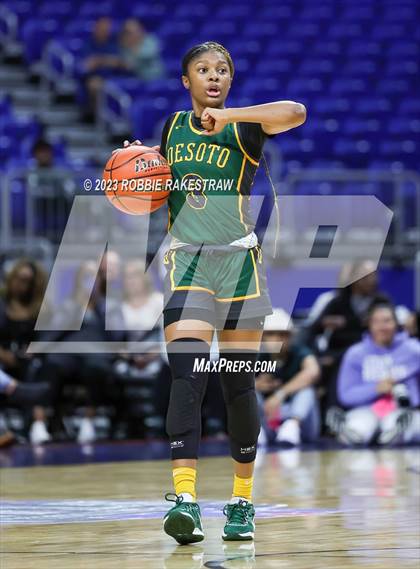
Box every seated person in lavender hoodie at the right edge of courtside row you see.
[327,304,420,445]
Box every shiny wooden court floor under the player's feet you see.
[0,449,420,569]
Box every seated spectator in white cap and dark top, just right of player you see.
[256,309,320,446]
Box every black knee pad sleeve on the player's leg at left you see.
[166,338,210,459]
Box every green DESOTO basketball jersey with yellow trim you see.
[161,111,262,245]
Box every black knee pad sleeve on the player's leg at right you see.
[220,350,261,462]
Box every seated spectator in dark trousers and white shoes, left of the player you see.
[30,253,124,444]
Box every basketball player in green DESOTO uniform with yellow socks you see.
[125,42,306,544]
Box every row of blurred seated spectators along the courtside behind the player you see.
[0,251,420,446]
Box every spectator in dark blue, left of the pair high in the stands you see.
[83,17,124,120]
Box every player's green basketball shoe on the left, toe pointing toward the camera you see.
[163,493,204,545]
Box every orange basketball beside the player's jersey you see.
[103,146,172,215]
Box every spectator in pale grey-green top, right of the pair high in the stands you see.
[120,18,164,81]
